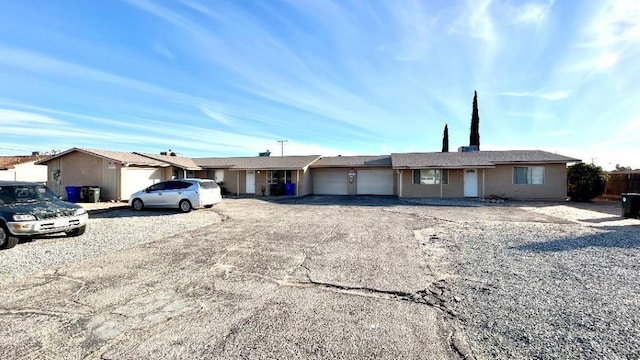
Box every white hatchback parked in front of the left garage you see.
[129,179,222,212]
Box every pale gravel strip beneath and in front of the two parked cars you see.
[0,208,221,281]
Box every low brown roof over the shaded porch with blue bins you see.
[193,155,320,170]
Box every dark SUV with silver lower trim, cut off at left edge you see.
[0,181,89,249]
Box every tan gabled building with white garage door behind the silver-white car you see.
[36,148,172,201]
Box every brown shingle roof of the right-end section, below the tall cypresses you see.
[391,150,580,169]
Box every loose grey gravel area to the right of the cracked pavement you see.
[404,204,640,359]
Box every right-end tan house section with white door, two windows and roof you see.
[391,150,580,200]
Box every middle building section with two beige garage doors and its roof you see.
[311,155,396,195]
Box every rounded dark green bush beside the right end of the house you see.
[567,163,607,202]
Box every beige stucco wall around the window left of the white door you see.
[396,169,462,198]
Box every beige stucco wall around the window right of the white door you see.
[479,163,567,200]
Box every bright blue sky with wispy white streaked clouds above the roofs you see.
[0,0,640,169]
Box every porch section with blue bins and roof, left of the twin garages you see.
[193,155,320,196]
